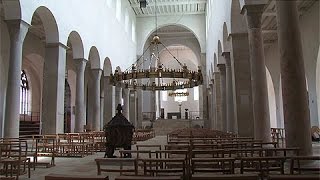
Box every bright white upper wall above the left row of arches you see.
[7,0,136,68]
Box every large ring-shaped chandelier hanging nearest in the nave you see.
[110,0,203,91]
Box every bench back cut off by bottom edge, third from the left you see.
[191,174,260,180]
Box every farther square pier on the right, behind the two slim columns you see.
[213,72,223,131]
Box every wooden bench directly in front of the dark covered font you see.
[95,158,138,175]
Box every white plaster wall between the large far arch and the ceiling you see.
[136,15,206,54]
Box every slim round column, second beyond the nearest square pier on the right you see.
[217,64,228,132]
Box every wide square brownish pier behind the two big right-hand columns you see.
[230,33,254,137]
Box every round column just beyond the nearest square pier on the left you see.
[74,59,87,132]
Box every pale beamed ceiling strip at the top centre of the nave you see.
[128,0,207,17]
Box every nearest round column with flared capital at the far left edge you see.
[3,20,30,138]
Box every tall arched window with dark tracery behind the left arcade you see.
[20,70,29,114]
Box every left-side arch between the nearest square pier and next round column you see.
[67,31,84,59]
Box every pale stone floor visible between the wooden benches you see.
[11,136,320,180]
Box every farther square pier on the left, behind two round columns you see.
[103,76,113,125]
